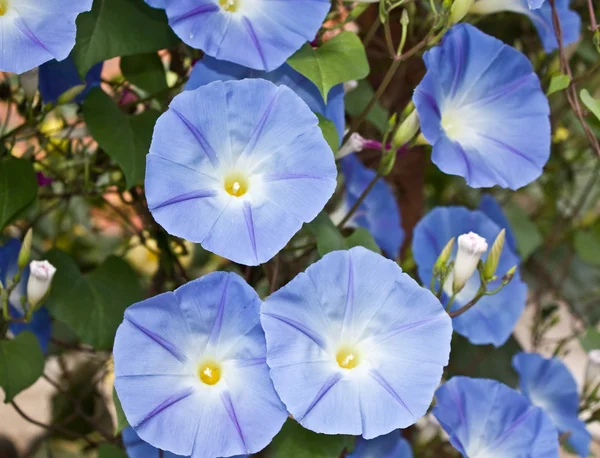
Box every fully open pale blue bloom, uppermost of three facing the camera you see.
[146,79,337,265]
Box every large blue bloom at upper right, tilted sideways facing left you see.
[413,24,550,189]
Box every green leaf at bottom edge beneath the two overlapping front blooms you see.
[266,420,354,458]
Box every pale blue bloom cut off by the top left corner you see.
[0,0,93,73]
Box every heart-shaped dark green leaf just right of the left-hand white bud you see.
[46,250,143,350]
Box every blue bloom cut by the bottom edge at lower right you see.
[433,377,558,458]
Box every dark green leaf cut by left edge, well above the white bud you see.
[0,158,38,230]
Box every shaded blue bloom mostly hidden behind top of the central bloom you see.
[185,56,345,141]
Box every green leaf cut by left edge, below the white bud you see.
[0,332,44,403]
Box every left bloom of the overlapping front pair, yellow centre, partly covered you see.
[114,272,287,458]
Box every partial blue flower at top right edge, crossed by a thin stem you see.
[471,0,581,53]
